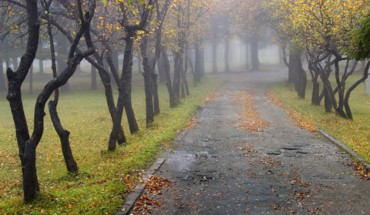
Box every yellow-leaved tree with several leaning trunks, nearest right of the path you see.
[266,0,369,119]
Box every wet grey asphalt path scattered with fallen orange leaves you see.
[132,71,370,215]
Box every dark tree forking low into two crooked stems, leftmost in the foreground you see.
[7,0,95,202]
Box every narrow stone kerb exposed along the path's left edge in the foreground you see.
[115,157,166,215]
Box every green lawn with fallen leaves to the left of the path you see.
[0,73,222,214]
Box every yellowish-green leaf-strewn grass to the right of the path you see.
[272,75,370,162]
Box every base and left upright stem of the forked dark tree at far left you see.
[7,0,40,202]
